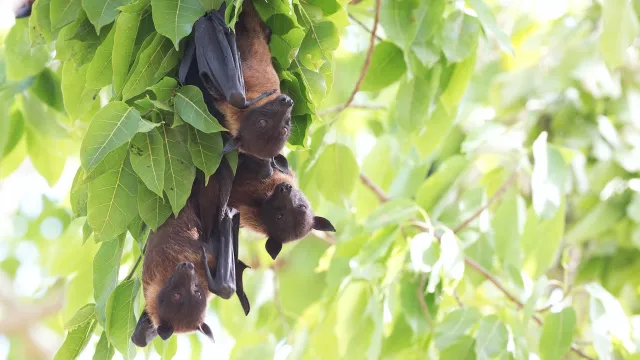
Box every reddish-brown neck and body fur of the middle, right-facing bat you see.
[229,169,297,235]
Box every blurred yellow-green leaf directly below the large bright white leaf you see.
[520,200,566,279]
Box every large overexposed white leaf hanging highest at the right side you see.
[531,132,569,219]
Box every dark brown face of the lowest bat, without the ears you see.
[156,262,207,339]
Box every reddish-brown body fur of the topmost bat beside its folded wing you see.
[215,0,280,136]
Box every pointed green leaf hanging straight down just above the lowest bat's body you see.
[161,125,196,216]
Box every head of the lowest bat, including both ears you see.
[131,262,213,347]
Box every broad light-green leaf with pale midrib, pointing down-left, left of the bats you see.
[80,101,141,172]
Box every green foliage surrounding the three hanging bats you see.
[0,0,640,359]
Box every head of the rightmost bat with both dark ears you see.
[260,182,336,259]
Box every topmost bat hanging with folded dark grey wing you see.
[179,0,293,159]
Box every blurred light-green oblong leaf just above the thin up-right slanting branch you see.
[416,155,469,213]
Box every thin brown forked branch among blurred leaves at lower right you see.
[360,170,594,360]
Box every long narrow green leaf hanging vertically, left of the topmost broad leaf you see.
[111,5,150,94]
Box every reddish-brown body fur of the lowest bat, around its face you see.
[142,201,216,332]
